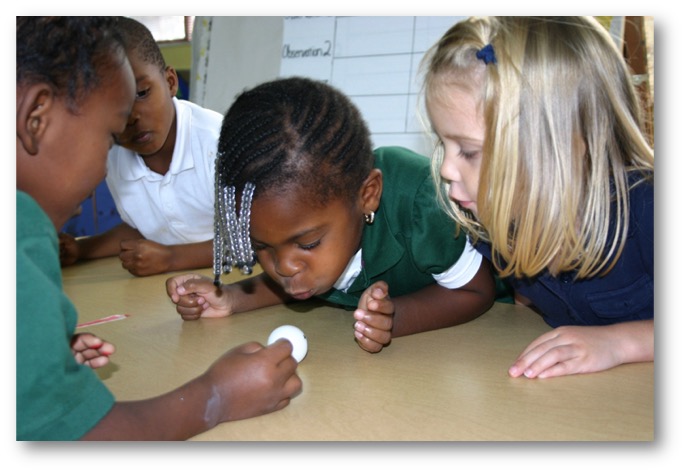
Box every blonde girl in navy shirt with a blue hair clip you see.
[424,17,654,378]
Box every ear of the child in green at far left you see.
[17,83,55,156]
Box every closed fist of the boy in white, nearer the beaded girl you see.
[119,239,174,277]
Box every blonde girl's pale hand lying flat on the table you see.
[509,326,622,379]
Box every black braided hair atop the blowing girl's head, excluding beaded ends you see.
[216,77,374,205]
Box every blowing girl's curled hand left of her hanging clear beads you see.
[166,274,231,320]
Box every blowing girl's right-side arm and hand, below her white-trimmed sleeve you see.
[354,258,495,352]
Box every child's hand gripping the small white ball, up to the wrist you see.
[205,340,302,422]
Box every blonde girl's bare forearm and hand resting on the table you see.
[509,320,654,379]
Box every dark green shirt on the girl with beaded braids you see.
[319,147,466,309]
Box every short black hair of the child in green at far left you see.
[17,16,123,111]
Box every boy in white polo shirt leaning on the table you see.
[60,17,223,276]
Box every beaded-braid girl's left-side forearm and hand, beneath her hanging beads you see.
[166,273,291,320]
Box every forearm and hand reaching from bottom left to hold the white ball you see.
[82,340,302,441]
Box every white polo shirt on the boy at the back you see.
[106,98,223,245]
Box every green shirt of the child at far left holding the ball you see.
[17,192,114,441]
